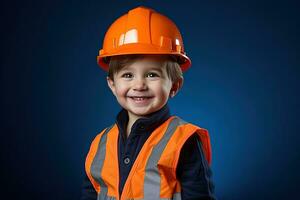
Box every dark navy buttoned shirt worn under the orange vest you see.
[81,105,215,200]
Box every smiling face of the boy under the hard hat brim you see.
[107,56,176,119]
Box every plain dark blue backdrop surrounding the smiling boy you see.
[0,0,300,200]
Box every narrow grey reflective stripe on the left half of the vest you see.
[91,125,113,200]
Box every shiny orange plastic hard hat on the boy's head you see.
[97,7,191,71]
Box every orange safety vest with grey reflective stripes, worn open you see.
[85,116,211,200]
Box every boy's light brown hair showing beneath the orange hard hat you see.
[108,54,183,83]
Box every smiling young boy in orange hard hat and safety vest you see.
[81,7,215,200]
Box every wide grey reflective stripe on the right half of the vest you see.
[144,117,186,200]
